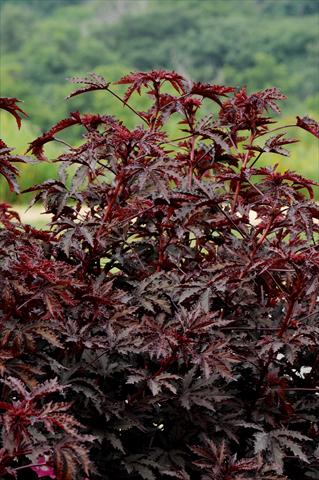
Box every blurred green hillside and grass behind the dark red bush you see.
[0,0,319,202]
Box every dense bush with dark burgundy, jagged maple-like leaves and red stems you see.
[0,71,319,480]
